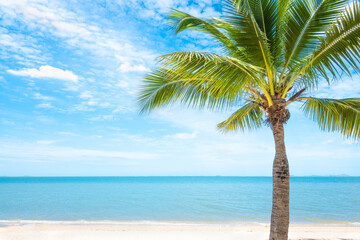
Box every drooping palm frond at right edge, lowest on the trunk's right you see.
[302,98,360,139]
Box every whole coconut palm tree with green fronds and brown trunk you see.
[138,0,360,240]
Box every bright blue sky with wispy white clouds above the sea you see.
[0,0,360,176]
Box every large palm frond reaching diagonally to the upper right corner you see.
[283,1,360,97]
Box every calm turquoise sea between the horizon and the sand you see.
[0,177,360,223]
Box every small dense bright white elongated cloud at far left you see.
[7,65,79,82]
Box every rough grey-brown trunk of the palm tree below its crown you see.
[270,123,290,240]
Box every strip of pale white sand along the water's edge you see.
[0,222,360,240]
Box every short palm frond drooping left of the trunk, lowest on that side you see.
[217,102,263,132]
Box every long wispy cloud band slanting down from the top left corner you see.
[0,0,156,66]
